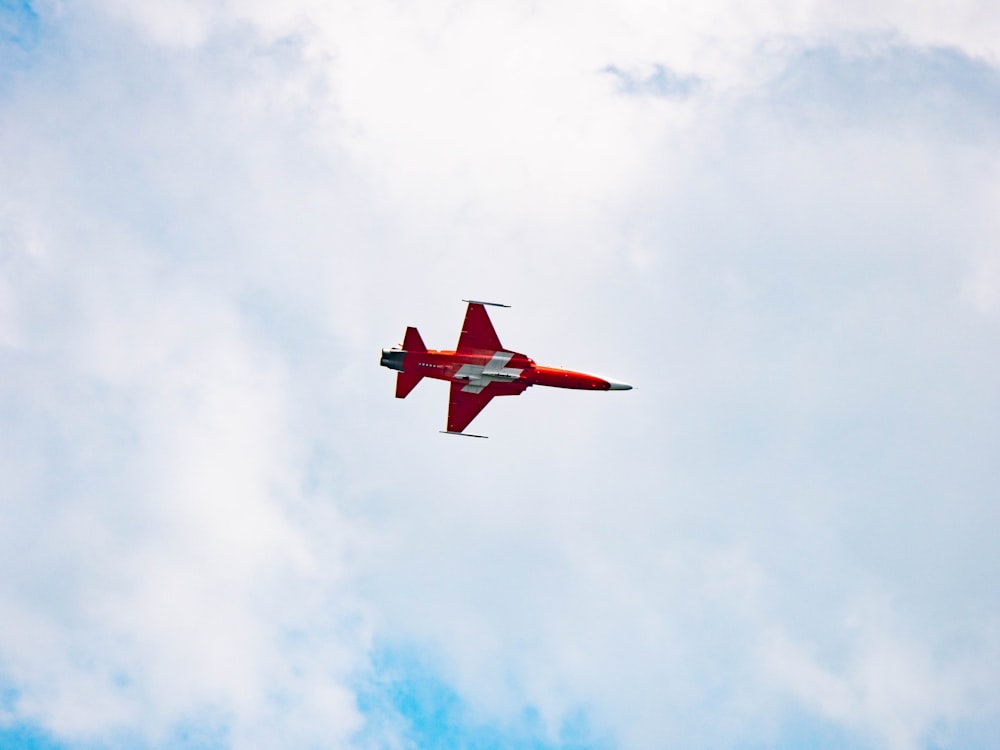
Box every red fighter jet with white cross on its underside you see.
[380,300,632,437]
